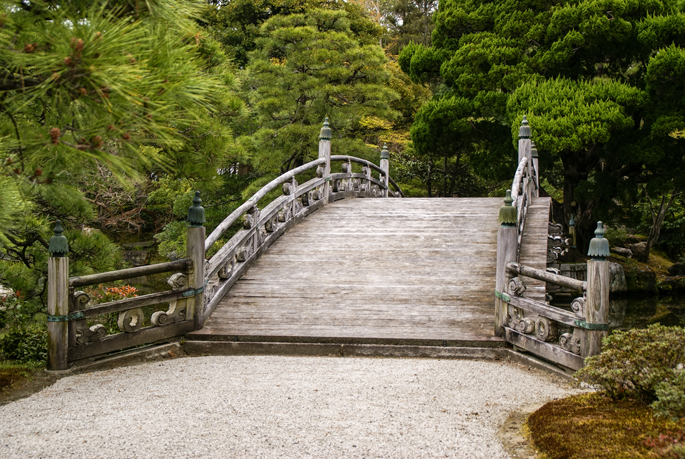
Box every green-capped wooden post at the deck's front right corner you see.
[495,190,518,337]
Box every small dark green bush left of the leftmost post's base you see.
[0,325,48,363]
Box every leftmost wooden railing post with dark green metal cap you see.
[48,220,69,371]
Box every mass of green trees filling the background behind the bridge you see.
[0,0,685,370]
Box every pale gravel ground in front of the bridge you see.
[0,356,577,459]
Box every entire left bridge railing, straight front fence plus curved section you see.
[48,119,404,371]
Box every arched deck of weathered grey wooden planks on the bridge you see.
[190,198,547,347]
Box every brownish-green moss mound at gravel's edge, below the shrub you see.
[528,393,685,459]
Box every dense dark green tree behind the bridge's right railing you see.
[399,0,685,252]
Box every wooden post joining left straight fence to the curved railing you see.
[186,191,205,330]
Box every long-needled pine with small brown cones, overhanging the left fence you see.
[0,0,235,310]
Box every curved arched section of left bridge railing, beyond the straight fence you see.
[196,127,404,328]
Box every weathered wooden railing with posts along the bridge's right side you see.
[495,117,609,370]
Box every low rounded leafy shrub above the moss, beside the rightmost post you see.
[575,325,685,401]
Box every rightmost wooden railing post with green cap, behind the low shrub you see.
[581,222,611,357]
